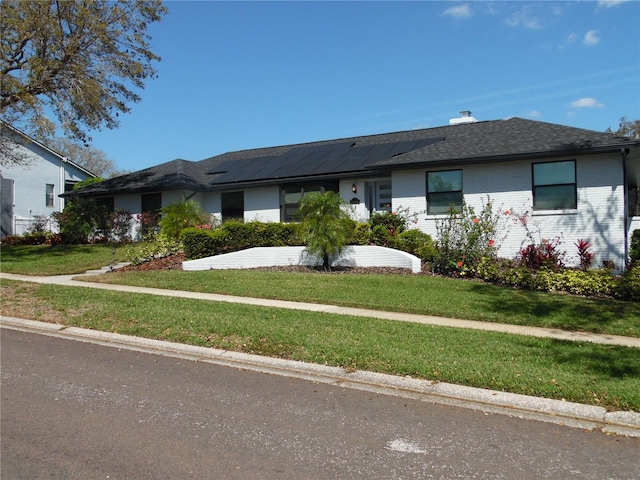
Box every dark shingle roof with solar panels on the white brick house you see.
[67,118,640,196]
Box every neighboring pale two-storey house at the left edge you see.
[0,122,95,238]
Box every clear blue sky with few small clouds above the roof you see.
[86,0,640,171]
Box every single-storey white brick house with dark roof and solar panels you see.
[66,112,640,268]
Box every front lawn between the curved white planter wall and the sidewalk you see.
[87,270,640,337]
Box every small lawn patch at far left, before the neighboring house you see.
[0,245,123,275]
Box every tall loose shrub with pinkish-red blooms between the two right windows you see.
[432,197,511,276]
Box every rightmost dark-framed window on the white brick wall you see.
[533,160,578,210]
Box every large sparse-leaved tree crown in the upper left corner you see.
[0,0,167,150]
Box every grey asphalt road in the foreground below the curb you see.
[0,329,640,480]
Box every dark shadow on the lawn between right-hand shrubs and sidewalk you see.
[464,283,638,334]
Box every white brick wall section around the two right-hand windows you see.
[392,155,625,267]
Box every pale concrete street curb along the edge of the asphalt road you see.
[0,316,640,438]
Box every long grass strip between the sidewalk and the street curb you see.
[0,276,640,411]
